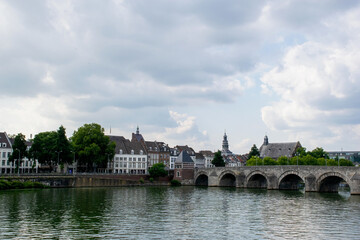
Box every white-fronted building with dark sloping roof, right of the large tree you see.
[109,136,148,174]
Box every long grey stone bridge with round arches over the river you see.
[194,165,360,194]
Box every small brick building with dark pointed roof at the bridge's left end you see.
[174,151,194,181]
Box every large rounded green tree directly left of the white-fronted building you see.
[70,123,115,171]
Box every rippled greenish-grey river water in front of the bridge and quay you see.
[0,187,360,239]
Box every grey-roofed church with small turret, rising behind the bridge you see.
[259,135,301,159]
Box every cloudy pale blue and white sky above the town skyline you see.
[0,0,360,154]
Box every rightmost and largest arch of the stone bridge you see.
[316,172,351,192]
